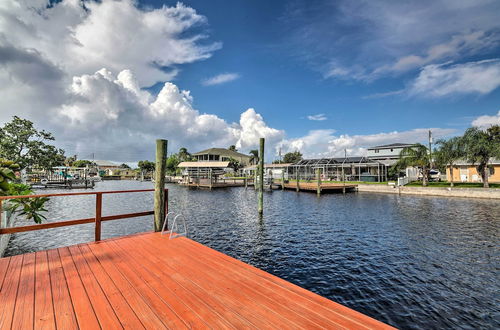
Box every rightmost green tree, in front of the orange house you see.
[463,125,500,188]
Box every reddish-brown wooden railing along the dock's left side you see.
[0,189,168,241]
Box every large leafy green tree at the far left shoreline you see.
[0,116,66,169]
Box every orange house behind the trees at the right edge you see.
[446,159,500,183]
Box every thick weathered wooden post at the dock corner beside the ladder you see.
[154,140,168,231]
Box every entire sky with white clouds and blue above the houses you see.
[0,0,500,162]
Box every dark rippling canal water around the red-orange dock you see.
[3,181,500,329]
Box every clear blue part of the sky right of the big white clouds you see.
[145,1,500,137]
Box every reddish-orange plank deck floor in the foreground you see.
[0,233,390,329]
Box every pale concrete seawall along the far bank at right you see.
[358,184,500,199]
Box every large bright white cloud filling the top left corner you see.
[0,0,221,86]
